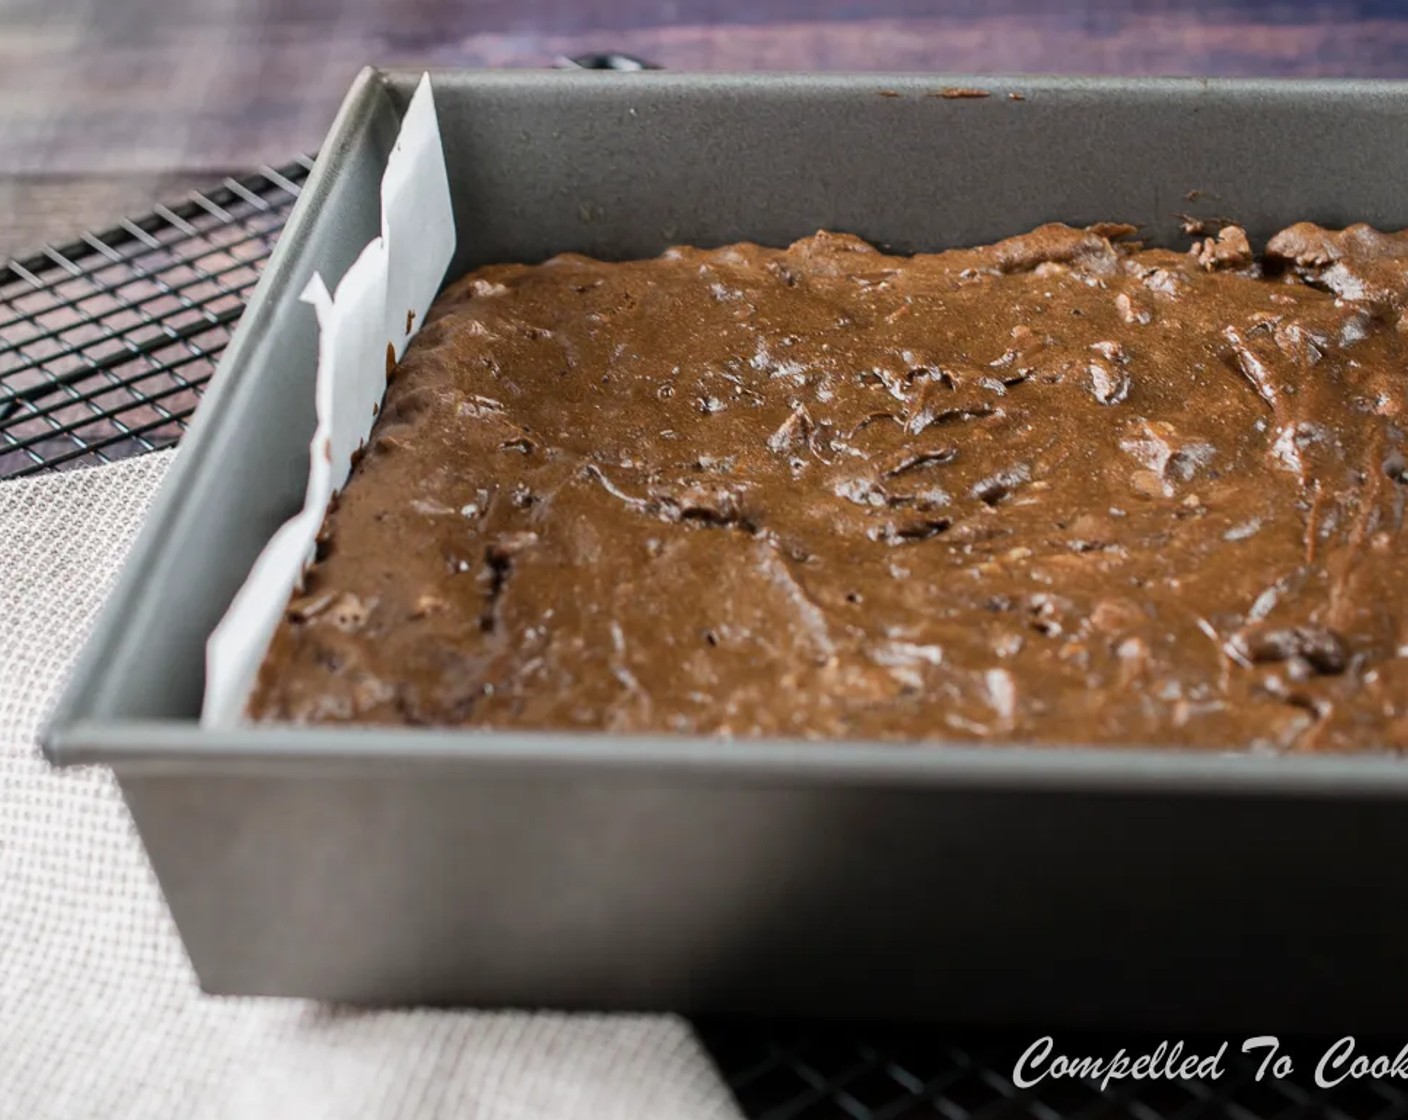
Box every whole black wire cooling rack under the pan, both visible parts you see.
[0,159,1408,1120]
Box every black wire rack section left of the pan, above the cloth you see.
[0,159,311,478]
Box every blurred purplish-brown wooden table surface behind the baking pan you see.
[0,0,1408,259]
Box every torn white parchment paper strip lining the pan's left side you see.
[201,75,455,727]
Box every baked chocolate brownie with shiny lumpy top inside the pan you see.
[251,224,1408,751]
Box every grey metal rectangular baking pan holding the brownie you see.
[46,70,1408,1031]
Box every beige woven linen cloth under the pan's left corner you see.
[0,454,738,1120]
